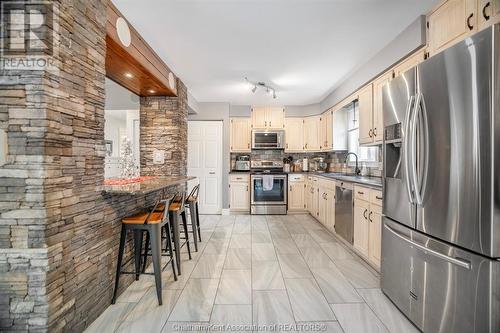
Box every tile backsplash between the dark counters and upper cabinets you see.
[231,149,382,177]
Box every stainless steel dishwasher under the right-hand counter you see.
[335,181,354,244]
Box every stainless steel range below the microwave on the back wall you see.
[250,161,287,215]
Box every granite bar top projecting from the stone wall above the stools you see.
[102,176,196,195]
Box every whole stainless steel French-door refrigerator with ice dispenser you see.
[381,25,500,332]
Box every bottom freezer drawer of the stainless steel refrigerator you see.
[381,218,500,333]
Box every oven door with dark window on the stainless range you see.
[251,175,287,205]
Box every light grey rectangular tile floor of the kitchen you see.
[86,215,418,333]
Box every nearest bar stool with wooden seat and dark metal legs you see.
[111,197,177,305]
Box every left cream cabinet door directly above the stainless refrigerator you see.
[427,0,478,56]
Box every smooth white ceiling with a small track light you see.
[113,0,436,105]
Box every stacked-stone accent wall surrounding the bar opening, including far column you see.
[0,0,187,332]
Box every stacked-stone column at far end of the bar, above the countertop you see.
[140,80,188,176]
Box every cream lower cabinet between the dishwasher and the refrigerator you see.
[354,186,382,267]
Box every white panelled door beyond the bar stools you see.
[188,121,222,214]
